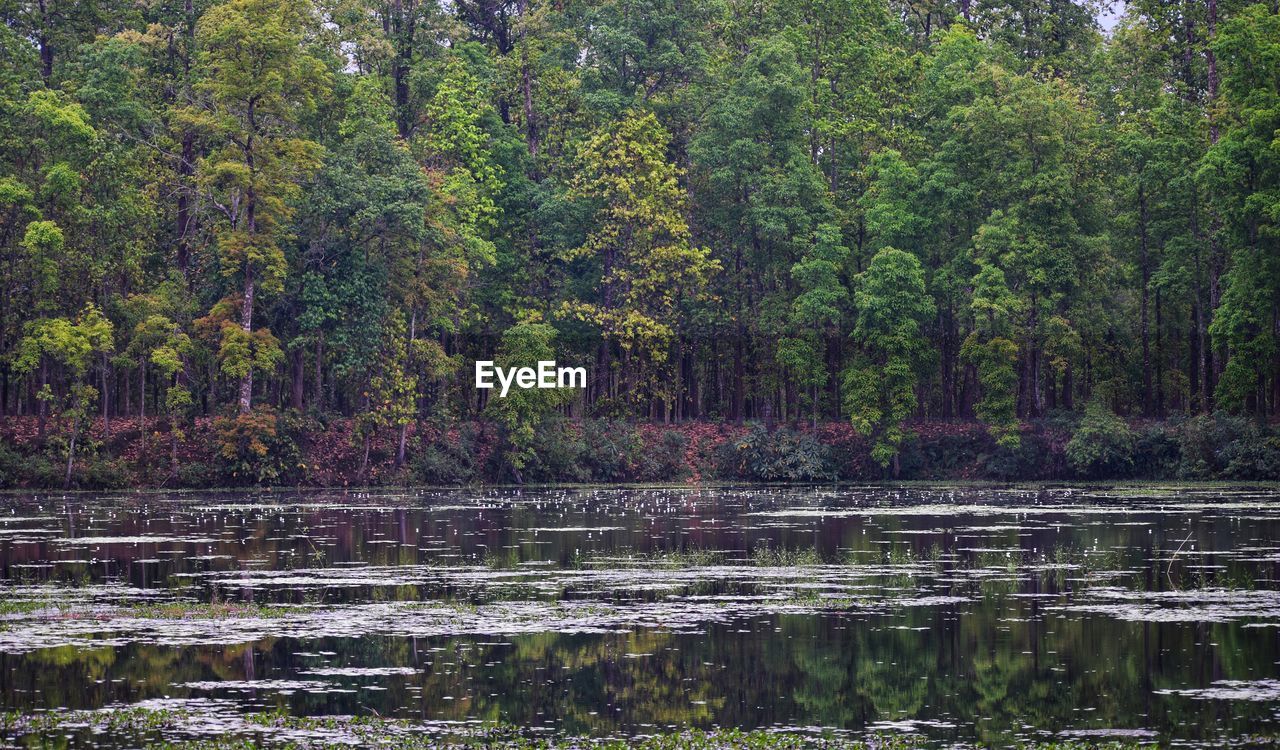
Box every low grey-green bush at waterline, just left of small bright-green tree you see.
[717,425,836,481]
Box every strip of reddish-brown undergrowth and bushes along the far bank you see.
[0,412,1280,490]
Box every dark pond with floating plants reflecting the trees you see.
[0,488,1280,746]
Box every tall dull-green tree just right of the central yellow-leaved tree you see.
[689,35,831,421]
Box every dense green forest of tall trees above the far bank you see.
[0,0,1280,484]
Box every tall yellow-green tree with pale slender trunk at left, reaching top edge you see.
[187,0,328,415]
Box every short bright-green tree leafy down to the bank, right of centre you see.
[844,247,933,475]
